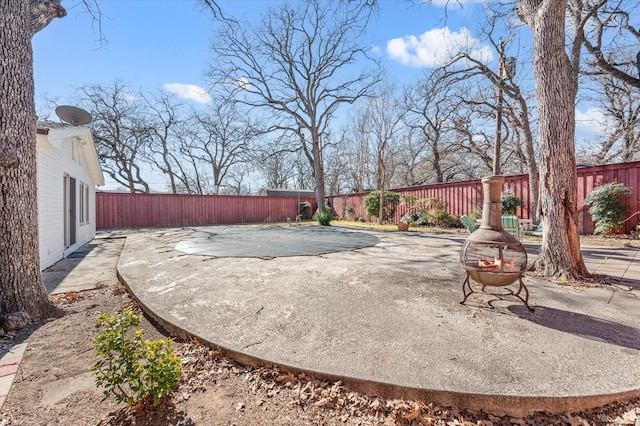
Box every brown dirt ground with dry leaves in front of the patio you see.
[0,235,640,426]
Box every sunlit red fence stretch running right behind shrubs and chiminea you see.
[328,161,640,234]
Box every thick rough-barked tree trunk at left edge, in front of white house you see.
[0,0,64,328]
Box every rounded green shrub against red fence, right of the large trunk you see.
[584,182,631,235]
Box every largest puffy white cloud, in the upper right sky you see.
[387,27,493,68]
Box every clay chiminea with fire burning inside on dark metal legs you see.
[460,176,533,311]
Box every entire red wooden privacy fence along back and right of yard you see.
[96,161,640,234]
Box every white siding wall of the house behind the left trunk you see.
[37,129,103,269]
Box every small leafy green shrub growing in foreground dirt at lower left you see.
[91,308,182,405]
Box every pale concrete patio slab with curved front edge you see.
[118,226,640,415]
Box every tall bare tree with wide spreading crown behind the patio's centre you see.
[210,0,382,210]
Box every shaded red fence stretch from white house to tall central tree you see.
[96,192,317,229]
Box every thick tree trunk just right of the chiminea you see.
[518,0,589,279]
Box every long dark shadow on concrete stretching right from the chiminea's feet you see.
[507,305,640,350]
